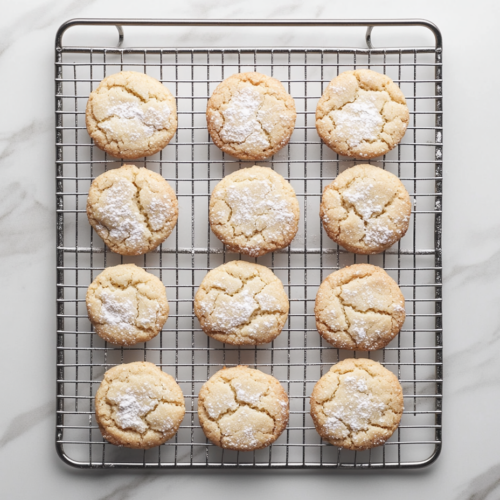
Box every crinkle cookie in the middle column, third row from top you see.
[194,260,289,345]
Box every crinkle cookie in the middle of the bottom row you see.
[198,366,288,451]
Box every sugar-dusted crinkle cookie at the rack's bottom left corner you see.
[95,361,186,450]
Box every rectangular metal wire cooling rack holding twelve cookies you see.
[55,20,442,469]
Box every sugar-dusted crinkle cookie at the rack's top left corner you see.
[85,71,177,160]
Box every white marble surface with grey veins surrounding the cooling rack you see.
[0,0,500,500]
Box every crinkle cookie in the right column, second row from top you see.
[320,165,411,254]
